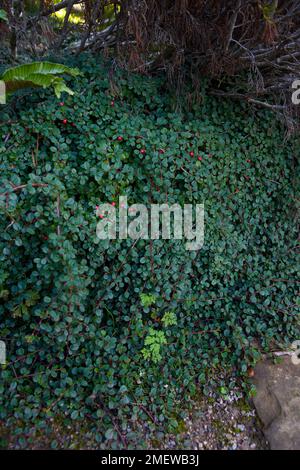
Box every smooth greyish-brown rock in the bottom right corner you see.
[253,356,300,450]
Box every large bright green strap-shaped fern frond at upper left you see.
[2,62,80,98]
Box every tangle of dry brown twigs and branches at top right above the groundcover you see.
[123,0,300,126]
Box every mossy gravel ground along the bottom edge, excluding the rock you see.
[0,390,268,450]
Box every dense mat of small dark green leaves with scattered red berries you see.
[0,55,299,448]
